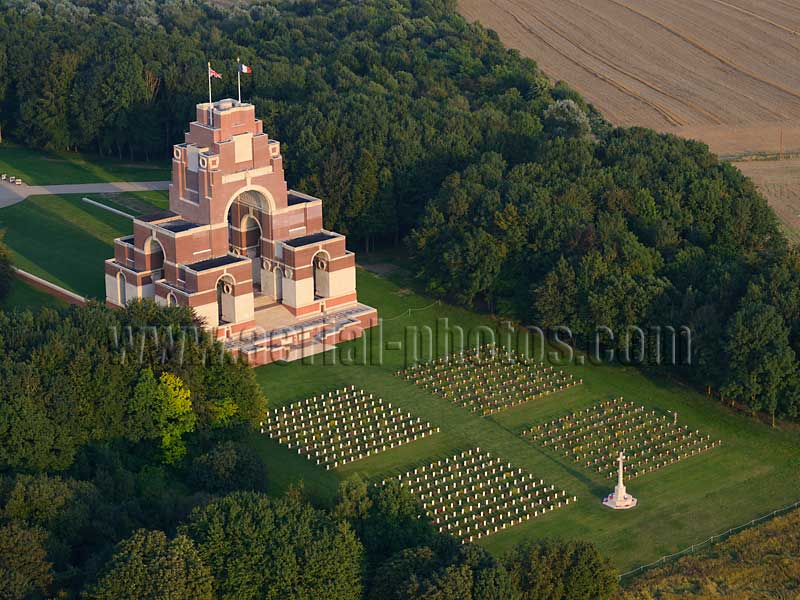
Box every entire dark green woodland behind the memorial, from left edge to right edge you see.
[0,0,800,417]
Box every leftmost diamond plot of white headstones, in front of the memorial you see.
[261,385,439,470]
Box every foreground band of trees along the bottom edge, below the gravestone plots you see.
[0,460,618,600]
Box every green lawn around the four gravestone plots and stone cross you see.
[251,270,800,571]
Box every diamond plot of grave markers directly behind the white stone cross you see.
[523,398,722,479]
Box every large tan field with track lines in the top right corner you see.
[459,0,800,157]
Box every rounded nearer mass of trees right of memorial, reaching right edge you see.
[410,129,800,421]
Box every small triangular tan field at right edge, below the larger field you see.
[733,159,800,242]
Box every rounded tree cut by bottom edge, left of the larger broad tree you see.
[84,529,214,600]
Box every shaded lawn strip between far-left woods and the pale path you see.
[0,142,171,185]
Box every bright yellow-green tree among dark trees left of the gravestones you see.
[156,372,196,464]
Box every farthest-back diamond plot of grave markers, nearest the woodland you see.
[397,345,583,416]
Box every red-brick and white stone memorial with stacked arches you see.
[105,99,377,365]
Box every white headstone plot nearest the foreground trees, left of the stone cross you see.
[383,448,577,543]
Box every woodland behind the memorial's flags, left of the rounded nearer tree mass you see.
[0,0,551,243]
